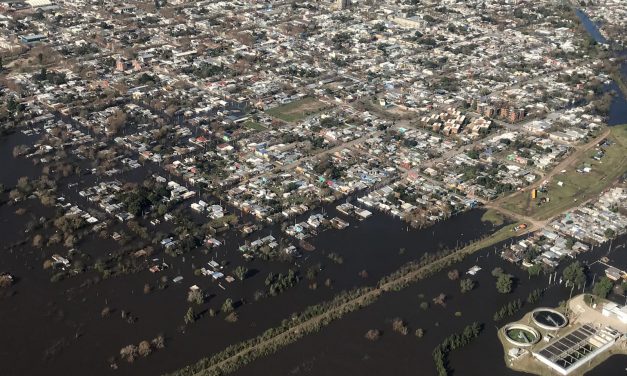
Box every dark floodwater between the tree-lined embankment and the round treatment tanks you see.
[235,236,627,376]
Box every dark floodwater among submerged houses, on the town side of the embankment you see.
[0,150,502,375]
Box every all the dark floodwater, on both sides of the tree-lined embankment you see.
[0,9,627,376]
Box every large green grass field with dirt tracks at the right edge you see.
[502,125,627,219]
